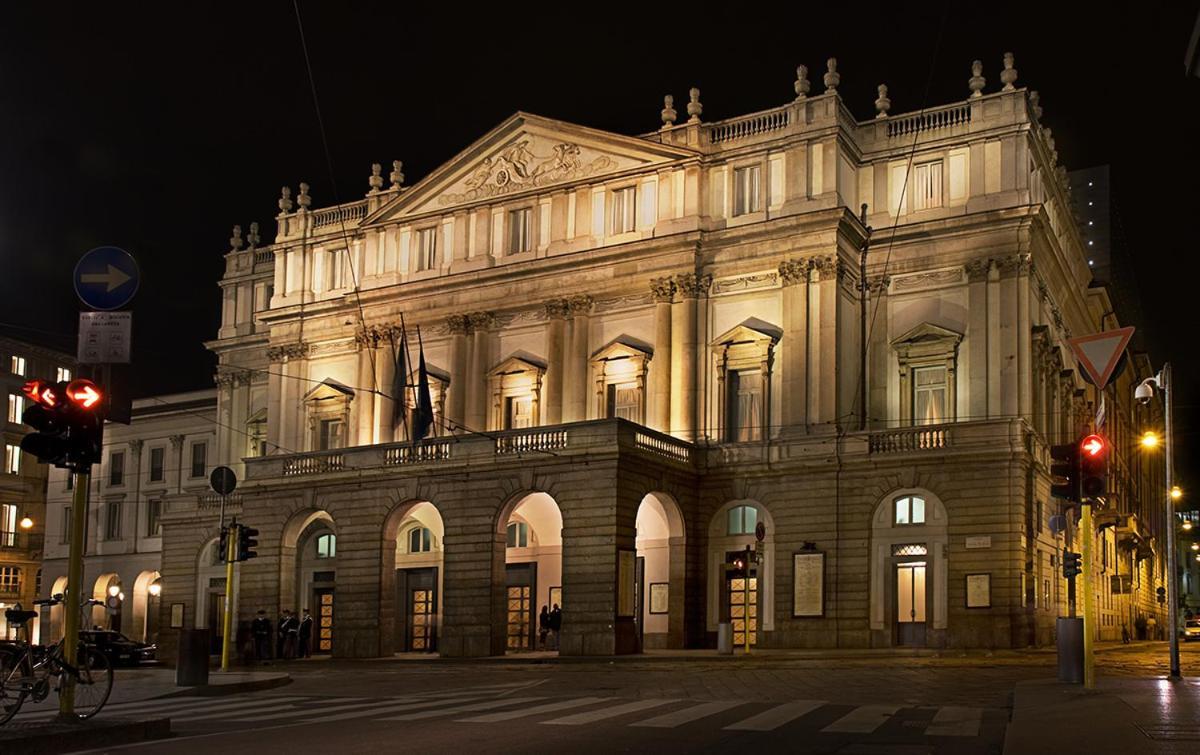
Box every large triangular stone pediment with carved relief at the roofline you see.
[362,113,697,226]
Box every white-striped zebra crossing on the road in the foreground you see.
[7,684,993,741]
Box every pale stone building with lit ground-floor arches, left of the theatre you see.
[42,389,216,641]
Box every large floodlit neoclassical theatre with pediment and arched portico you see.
[154,56,1163,657]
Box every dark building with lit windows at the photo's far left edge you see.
[0,332,74,637]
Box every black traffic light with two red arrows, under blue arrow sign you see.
[20,379,104,472]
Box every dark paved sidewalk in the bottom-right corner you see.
[1004,677,1200,755]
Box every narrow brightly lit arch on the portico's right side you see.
[636,492,686,649]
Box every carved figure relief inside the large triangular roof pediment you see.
[438,139,617,205]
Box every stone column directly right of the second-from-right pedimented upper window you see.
[779,259,809,435]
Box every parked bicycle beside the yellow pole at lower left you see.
[0,595,113,725]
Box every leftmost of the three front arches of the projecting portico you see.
[283,510,337,654]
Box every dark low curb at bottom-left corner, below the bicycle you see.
[0,718,172,755]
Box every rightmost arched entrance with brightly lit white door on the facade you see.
[870,489,948,647]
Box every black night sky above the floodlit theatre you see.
[0,0,1200,489]
